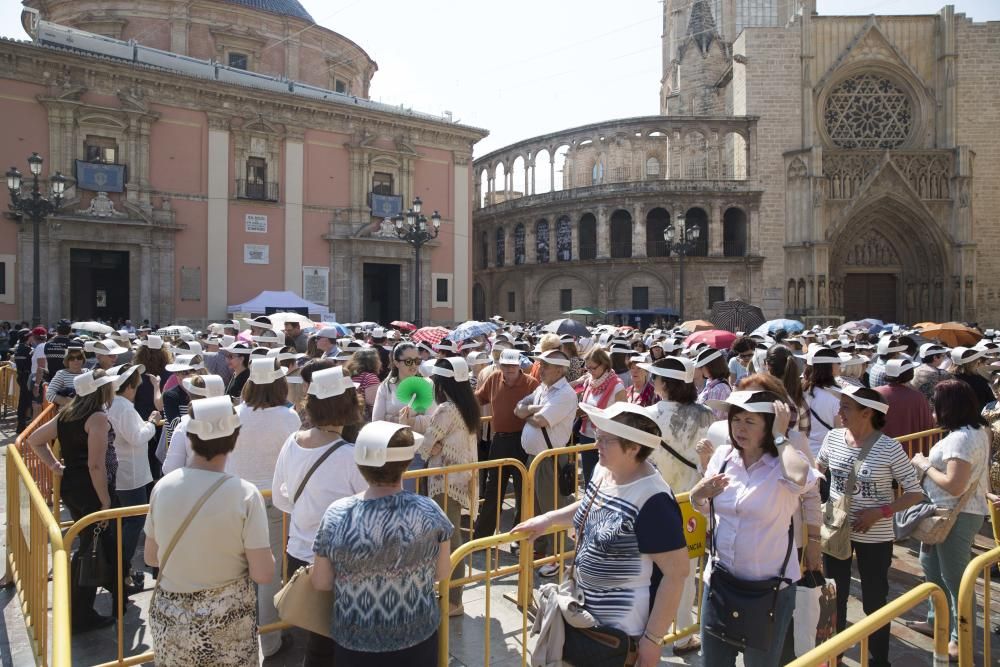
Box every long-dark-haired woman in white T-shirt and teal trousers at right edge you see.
[906,380,991,659]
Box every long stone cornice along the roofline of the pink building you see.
[0,40,488,151]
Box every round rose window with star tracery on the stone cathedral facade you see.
[823,73,913,150]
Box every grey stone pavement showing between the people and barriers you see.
[0,414,1000,667]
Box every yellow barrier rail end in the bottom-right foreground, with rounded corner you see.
[788,583,944,667]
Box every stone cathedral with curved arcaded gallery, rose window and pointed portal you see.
[473,0,1000,323]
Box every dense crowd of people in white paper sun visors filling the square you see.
[13,316,1000,667]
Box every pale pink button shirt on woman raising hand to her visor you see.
[695,445,819,581]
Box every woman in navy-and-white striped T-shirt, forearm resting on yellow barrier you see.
[514,402,688,667]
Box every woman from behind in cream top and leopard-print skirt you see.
[145,396,274,667]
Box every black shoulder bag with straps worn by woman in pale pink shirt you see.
[701,462,792,651]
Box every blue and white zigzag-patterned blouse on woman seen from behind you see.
[313,491,454,653]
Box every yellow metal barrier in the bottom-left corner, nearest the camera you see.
[4,446,70,667]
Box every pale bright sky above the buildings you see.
[0,0,1000,156]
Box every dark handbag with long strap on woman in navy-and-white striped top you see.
[559,482,639,667]
